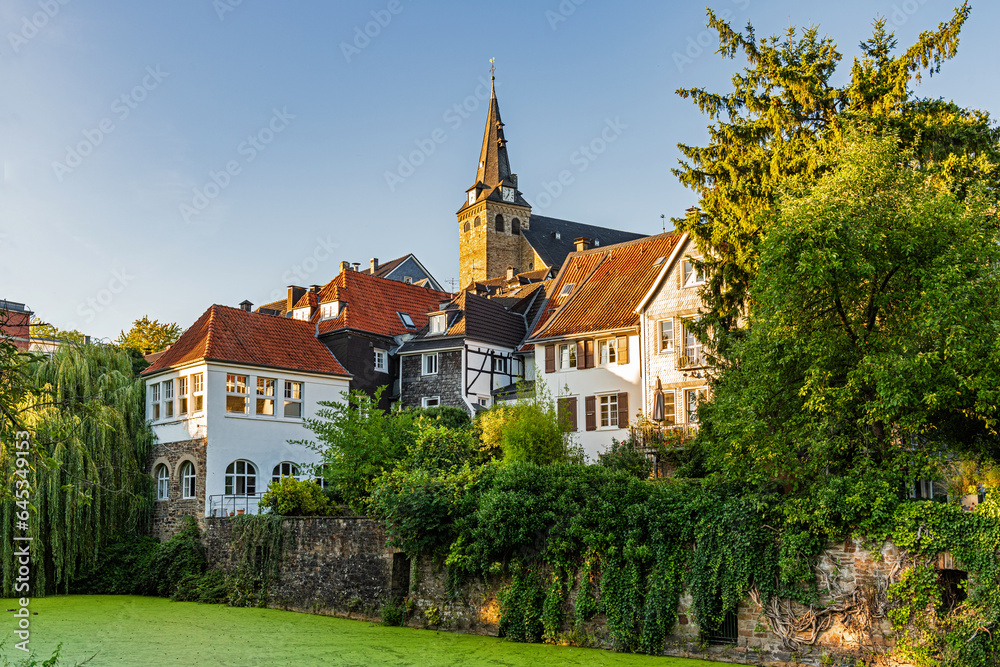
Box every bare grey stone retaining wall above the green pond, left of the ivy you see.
[205,517,410,620]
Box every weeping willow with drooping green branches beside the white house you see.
[0,345,153,596]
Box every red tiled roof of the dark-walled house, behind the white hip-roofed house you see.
[314,271,452,336]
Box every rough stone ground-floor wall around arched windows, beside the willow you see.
[147,438,206,540]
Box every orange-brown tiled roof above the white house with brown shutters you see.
[530,233,681,342]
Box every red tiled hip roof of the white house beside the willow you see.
[142,305,350,376]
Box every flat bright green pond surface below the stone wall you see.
[0,595,736,667]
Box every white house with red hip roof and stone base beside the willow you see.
[142,306,351,537]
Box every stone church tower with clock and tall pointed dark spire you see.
[458,77,531,288]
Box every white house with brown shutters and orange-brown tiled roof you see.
[527,234,680,460]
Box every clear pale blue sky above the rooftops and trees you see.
[0,0,1000,340]
